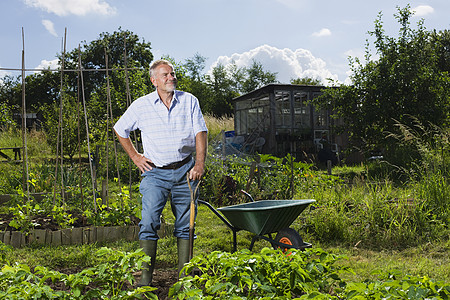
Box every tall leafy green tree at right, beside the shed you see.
[315,6,450,162]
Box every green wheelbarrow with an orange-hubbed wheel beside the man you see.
[198,191,315,252]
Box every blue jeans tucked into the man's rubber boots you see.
[139,159,198,240]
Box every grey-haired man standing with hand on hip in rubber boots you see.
[114,60,207,286]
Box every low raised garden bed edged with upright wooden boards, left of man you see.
[0,193,183,248]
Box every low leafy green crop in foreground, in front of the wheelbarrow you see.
[169,248,348,299]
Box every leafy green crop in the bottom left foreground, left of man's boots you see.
[0,247,157,299]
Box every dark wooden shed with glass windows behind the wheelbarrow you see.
[233,84,339,159]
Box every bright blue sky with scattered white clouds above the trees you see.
[0,0,450,83]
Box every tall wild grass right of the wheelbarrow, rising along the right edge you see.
[296,120,450,249]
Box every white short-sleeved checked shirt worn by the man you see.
[114,91,208,167]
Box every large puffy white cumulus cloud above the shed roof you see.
[211,45,338,84]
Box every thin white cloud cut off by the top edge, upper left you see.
[23,0,116,16]
